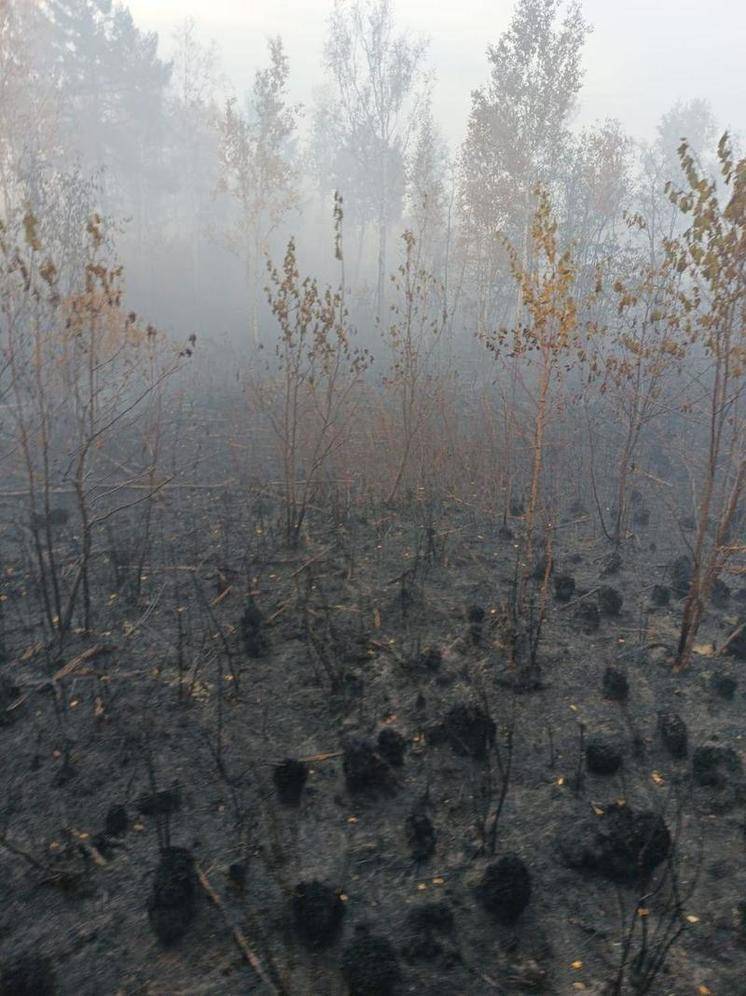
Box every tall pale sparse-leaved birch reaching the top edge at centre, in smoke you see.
[325,0,425,320]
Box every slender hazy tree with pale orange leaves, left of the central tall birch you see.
[218,38,299,343]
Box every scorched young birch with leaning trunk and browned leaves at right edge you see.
[665,134,746,670]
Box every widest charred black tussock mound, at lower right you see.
[560,803,671,882]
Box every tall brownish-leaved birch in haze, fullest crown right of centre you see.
[460,0,589,332]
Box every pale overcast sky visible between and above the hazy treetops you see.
[125,0,746,146]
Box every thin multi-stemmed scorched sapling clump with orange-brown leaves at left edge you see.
[0,214,186,648]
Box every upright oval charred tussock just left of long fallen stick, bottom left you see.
[148,847,197,945]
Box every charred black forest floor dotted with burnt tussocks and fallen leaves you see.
[0,462,746,996]
